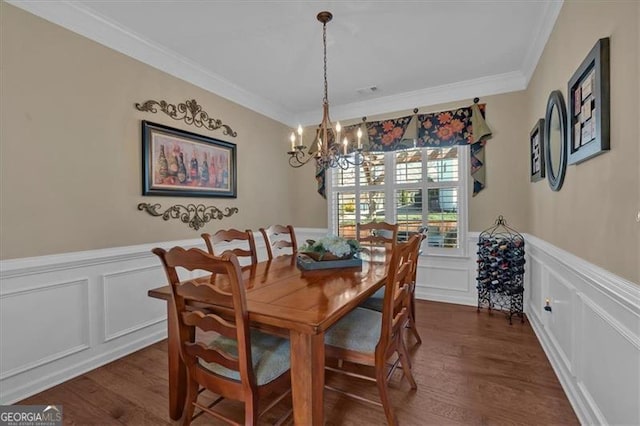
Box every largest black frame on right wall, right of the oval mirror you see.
[567,37,610,164]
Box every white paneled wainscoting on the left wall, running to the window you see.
[0,228,326,404]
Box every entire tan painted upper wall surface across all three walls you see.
[0,1,640,282]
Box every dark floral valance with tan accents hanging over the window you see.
[316,103,491,197]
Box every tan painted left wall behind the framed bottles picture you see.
[0,2,293,259]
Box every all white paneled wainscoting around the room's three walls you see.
[0,228,640,425]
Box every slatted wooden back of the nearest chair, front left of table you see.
[153,247,256,390]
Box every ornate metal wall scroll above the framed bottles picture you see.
[136,99,238,138]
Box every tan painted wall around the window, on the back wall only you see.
[296,92,529,232]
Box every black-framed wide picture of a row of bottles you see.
[142,121,237,198]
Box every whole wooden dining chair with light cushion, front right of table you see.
[325,238,417,425]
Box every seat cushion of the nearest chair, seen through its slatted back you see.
[200,329,290,386]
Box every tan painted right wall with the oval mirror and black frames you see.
[523,1,640,283]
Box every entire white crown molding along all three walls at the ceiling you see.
[4,0,563,127]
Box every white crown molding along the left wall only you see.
[5,0,293,123]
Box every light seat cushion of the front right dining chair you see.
[324,308,382,353]
